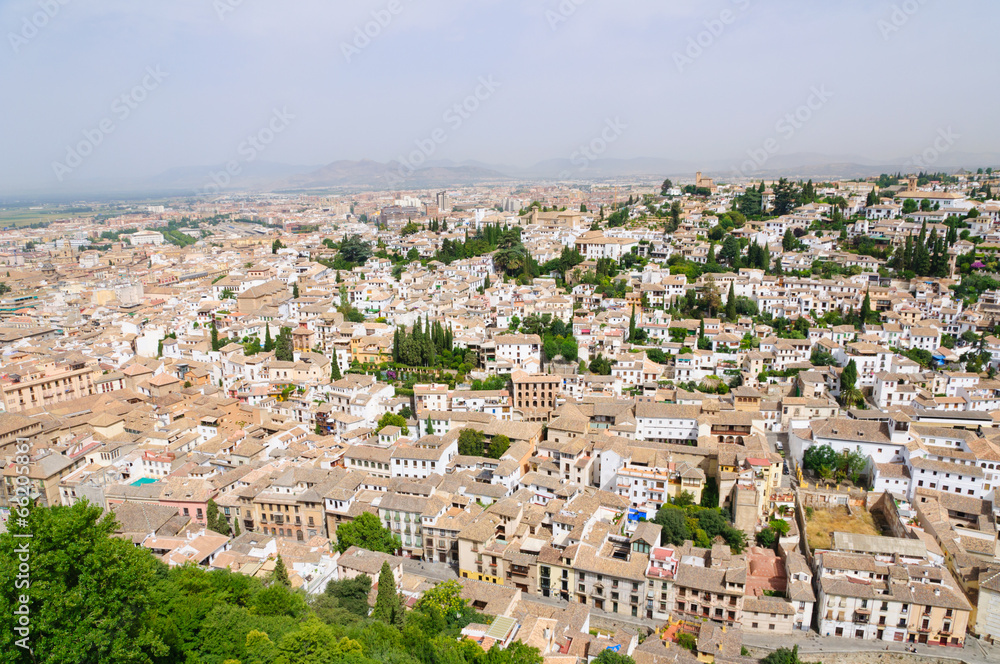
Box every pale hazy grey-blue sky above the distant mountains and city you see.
[0,0,1000,191]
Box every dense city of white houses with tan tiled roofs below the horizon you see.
[0,168,1000,664]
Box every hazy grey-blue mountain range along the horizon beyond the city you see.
[4,152,1000,200]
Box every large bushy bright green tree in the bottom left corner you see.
[0,502,167,664]
